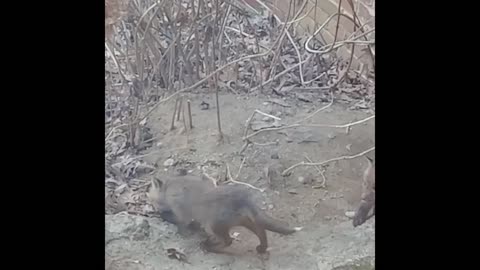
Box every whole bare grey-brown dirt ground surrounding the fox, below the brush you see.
[105,93,375,270]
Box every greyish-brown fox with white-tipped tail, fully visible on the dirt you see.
[148,176,302,253]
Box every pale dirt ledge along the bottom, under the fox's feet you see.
[105,213,375,270]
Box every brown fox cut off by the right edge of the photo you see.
[353,157,375,227]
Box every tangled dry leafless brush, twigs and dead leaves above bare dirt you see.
[105,0,375,219]
